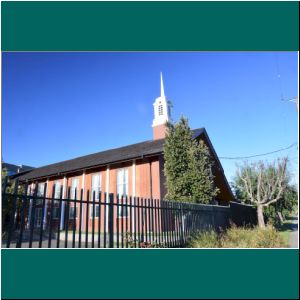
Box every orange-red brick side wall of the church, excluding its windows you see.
[27,157,161,232]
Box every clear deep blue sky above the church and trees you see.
[2,52,298,181]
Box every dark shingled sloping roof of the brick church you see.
[20,128,205,180]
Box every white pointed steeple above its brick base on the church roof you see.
[152,73,172,127]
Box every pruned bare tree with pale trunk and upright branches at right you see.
[237,157,288,228]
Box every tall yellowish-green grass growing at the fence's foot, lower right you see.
[187,226,287,248]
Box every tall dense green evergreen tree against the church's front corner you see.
[164,117,218,203]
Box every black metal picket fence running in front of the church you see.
[2,180,230,248]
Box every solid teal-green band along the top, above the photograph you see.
[1,1,299,51]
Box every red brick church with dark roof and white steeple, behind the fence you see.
[19,74,234,230]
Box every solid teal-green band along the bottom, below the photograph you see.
[2,249,299,299]
